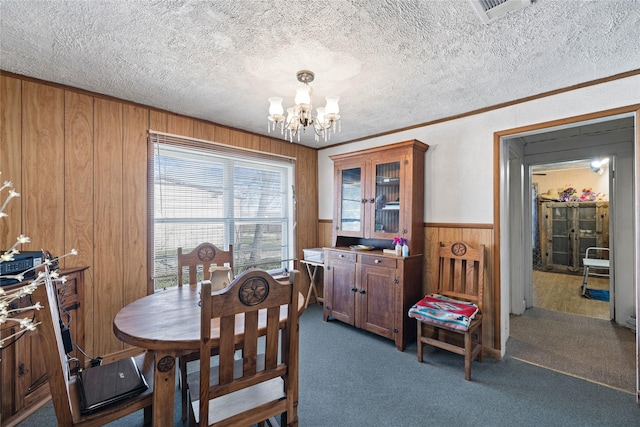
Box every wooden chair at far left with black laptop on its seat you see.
[32,270,153,427]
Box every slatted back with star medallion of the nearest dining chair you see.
[199,269,300,425]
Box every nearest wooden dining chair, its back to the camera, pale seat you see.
[187,269,300,426]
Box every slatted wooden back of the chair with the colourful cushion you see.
[437,242,485,309]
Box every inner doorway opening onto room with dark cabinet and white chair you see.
[529,160,614,320]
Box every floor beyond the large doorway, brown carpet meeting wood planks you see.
[506,270,636,393]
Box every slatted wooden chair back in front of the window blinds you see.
[178,242,233,286]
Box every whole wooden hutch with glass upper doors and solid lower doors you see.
[323,140,428,351]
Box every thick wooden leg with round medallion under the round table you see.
[153,350,176,426]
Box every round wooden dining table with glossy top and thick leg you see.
[113,285,304,426]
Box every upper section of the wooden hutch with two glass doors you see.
[331,140,429,254]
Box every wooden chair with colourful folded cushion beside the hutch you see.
[409,242,485,381]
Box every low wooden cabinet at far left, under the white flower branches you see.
[0,267,87,427]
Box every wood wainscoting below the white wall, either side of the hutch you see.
[318,220,500,359]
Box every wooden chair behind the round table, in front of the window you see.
[178,242,233,420]
